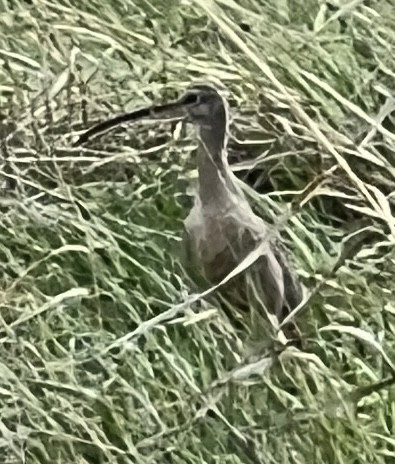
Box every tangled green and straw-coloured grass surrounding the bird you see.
[0,0,395,464]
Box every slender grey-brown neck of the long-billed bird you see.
[198,127,235,205]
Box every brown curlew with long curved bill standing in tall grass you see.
[74,84,303,338]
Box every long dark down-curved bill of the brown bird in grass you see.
[73,102,187,147]
